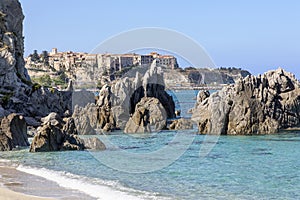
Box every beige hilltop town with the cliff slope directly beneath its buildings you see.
[25,48,178,88]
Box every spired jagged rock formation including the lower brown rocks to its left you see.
[73,61,175,133]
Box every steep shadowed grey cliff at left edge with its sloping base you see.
[0,0,72,122]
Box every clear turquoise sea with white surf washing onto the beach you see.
[0,90,300,200]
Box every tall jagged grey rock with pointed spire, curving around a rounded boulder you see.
[102,61,175,129]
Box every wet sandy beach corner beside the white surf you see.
[0,166,95,200]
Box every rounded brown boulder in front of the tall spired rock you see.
[124,97,167,133]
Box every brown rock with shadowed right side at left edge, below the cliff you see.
[0,113,29,151]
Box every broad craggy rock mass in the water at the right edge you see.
[192,69,300,135]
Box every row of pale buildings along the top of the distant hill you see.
[26,48,178,77]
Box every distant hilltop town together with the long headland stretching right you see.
[25,48,250,89]
